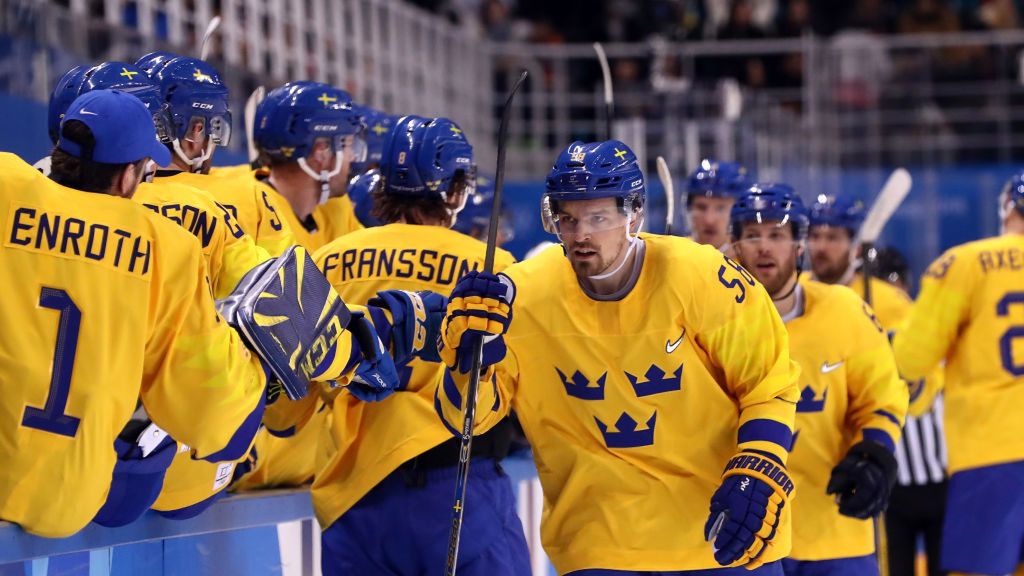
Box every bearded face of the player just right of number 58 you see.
[733,217,803,295]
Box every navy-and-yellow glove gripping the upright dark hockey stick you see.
[438,272,515,374]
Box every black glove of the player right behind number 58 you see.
[826,440,896,520]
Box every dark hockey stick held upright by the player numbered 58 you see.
[444,70,528,576]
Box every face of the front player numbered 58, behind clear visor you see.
[558,198,630,277]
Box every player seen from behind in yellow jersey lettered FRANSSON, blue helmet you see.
[313,116,529,576]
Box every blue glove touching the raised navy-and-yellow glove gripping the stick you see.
[368,290,447,365]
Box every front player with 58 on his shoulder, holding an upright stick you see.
[435,140,799,576]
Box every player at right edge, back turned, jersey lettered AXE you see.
[893,173,1024,574]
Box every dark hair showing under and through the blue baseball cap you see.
[50,120,142,194]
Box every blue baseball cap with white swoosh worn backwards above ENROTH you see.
[57,90,171,166]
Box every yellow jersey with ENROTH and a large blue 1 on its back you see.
[0,153,265,537]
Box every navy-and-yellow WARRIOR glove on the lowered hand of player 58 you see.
[705,451,794,570]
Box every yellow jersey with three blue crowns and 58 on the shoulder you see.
[435,234,800,574]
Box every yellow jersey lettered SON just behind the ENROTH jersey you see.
[132,177,270,298]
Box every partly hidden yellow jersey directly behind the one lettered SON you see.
[169,167,296,256]
